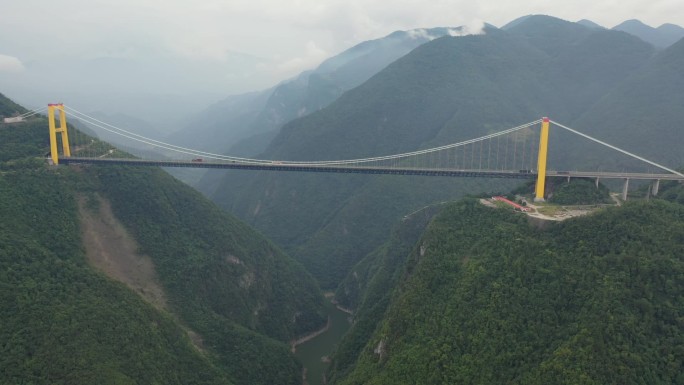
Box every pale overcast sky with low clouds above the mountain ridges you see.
[0,0,684,120]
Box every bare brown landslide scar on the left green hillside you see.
[78,196,168,310]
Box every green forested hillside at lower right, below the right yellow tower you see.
[337,201,684,384]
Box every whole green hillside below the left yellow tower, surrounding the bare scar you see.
[0,95,325,385]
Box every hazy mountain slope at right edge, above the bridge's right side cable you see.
[573,39,684,168]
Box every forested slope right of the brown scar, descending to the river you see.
[88,167,325,384]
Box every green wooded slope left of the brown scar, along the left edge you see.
[0,119,230,385]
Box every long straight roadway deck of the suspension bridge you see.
[59,157,684,182]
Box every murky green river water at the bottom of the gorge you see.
[295,302,351,385]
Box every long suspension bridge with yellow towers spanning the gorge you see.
[37,103,684,201]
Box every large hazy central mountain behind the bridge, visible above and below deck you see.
[211,16,664,287]
